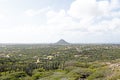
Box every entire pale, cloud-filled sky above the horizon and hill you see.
[0,0,120,43]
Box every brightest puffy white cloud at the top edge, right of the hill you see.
[68,0,114,19]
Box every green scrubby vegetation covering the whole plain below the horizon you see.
[0,44,120,80]
